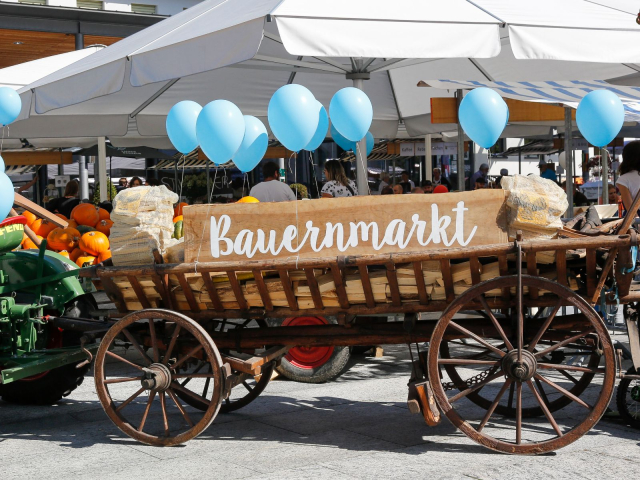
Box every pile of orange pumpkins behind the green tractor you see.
[22,203,113,267]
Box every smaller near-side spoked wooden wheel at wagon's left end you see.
[95,309,223,446]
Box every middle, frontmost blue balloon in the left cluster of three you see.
[196,100,245,165]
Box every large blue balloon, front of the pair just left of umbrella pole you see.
[267,84,319,152]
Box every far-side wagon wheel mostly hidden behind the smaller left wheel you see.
[177,319,275,413]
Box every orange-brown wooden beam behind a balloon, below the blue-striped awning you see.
[431,97,576,123]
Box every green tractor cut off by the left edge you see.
[0,216,106,405]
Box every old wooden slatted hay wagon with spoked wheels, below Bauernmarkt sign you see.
[81,190,640,454]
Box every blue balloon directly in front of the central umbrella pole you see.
[329,87,373,142]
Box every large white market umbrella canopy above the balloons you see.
[11,0,640,195]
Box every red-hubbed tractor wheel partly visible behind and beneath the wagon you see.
[269,316,351,383]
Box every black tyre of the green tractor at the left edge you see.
[0,295,96,405]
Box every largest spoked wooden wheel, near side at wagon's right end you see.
[428,276,615,454]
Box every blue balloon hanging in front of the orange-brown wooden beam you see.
[458,87,509,148]
